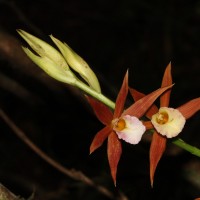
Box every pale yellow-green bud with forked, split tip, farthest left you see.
[17,30,77,84]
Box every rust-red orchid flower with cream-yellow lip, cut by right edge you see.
[130,63,200,186]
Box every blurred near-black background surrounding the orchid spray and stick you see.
[0,0,200,200]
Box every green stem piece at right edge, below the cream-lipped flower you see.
[172,138,200,157]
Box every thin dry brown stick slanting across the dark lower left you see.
[0,109,127,200]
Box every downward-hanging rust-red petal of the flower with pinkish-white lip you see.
[107,132,122,186]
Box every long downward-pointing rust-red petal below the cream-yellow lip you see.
[150,131,167,187]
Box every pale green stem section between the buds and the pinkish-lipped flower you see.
[75,80,115,110]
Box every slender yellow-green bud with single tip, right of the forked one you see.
[50,35,101,93]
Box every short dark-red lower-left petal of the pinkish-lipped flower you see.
[90,126,112,154]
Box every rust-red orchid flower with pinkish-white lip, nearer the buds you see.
[87,72,172,186]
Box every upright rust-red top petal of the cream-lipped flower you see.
[160,62,172,107]
